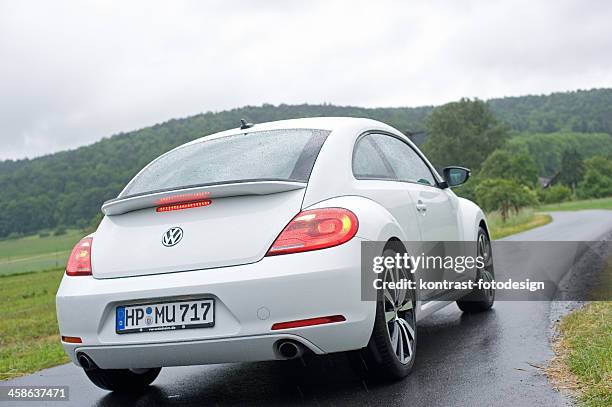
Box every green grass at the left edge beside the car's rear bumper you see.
[0,270,68,380]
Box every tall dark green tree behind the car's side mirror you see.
[423,99,507,171]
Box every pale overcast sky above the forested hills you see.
[0,0,612,159]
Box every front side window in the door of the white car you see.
[372,134,436,186]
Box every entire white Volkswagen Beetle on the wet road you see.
[57,118,494,391]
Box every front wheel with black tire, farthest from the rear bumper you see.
[457,227,495,313]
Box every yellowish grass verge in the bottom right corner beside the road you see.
[558,301,612,407]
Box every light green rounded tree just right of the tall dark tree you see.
[480,150,538,188]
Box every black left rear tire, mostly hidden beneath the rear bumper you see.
[85,367,161,393]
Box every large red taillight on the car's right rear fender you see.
[266,208,359,256]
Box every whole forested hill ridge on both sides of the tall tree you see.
[0,89,612,237]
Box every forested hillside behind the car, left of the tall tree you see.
[0,105,432,238]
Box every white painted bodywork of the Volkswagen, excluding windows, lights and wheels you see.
[57,118,486,369]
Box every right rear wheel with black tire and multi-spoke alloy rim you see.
[351,243,417,380]
